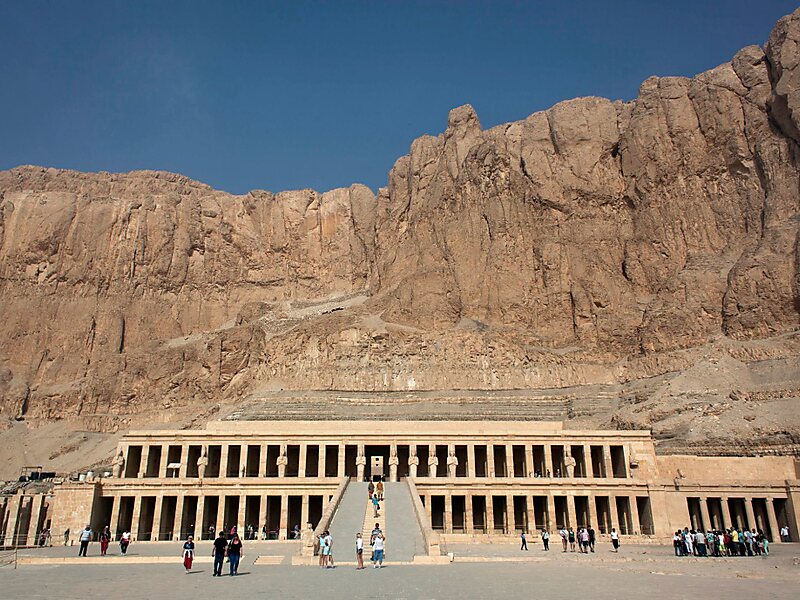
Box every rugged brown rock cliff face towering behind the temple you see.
[0,11,800,458]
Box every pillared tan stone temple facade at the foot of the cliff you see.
[0,421,800,554]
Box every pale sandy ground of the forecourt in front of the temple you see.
[0,542,800,600]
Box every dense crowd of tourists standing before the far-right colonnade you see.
[672,527,769,557]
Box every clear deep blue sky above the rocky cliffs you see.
[0,0,797,193]
